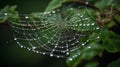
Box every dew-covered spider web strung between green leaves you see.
[10,3,100,58]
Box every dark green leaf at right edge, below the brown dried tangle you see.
[101,29,120,53]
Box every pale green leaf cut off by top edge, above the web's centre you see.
[45,0,68,11]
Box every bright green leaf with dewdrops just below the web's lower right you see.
[67,43,103,67]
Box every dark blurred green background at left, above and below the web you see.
[0,0,67,67]
